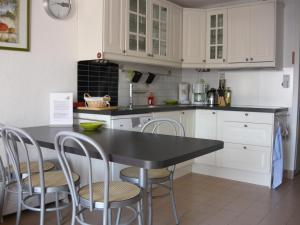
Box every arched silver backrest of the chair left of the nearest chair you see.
[2,127,45,196]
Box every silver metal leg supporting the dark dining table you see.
[139,168,152,225]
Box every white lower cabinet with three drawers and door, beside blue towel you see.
[193,110,274,186]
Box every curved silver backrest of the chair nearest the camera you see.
[55,131,109,224]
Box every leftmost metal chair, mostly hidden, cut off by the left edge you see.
[0,123,55,223]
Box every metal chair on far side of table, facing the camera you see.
[119,118,185,224]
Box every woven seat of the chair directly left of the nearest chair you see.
[24,171,79,188]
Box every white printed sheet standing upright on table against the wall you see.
[50,93,73,126]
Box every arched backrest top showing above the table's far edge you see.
[142,118,185,137]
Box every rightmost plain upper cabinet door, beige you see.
[250,2,276,62]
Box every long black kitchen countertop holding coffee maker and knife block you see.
[74,105,288,116]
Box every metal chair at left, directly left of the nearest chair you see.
[2,127,79,225]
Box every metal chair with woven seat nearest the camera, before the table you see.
[55,131,142,225]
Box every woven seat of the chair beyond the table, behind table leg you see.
[120,167,171,179]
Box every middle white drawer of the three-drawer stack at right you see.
[223,122,273,146]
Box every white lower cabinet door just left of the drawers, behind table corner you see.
[195,110,217,165]
